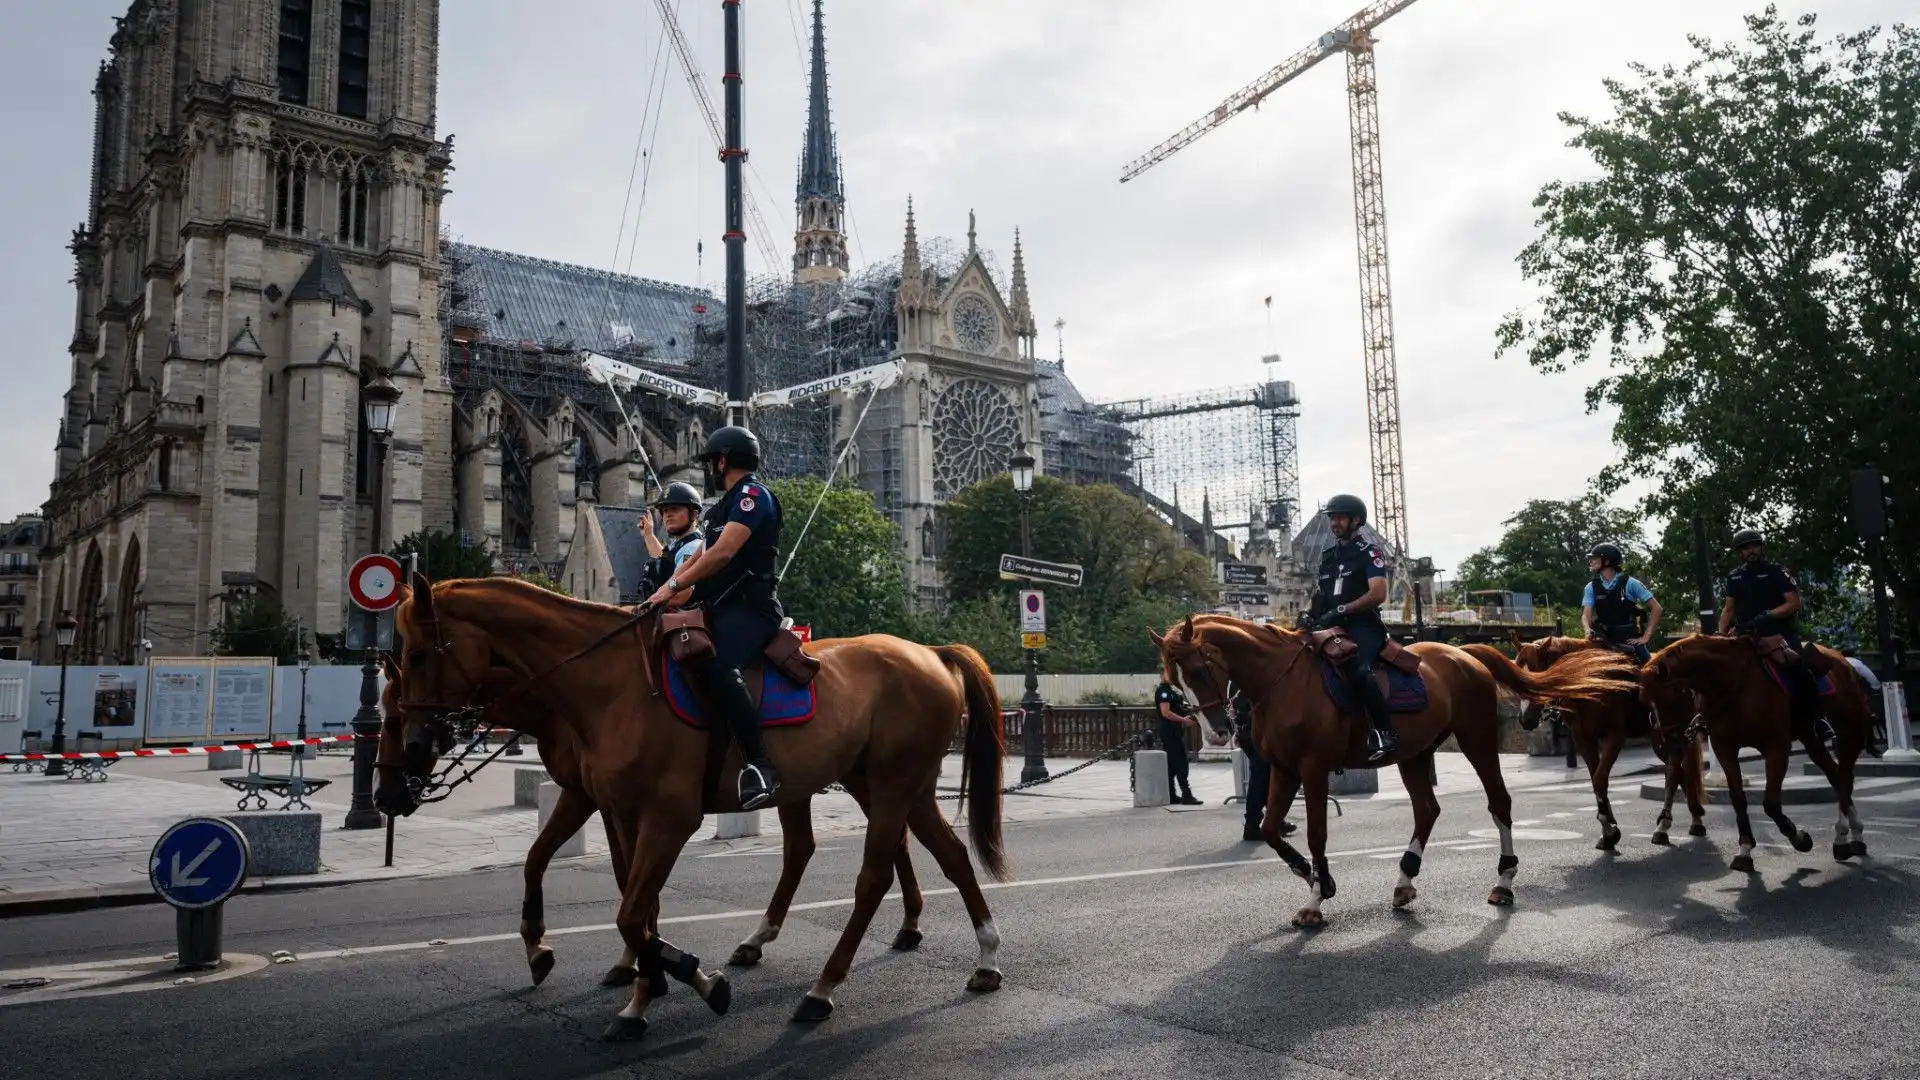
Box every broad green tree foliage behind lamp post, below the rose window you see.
[925,475,1219,673]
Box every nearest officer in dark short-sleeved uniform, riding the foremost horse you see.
[647,427,785,811]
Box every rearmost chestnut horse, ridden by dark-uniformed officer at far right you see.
[1640,634,1872,872]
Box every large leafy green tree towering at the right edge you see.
[1498,6,1920,625]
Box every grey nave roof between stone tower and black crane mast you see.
[445,242,720,361]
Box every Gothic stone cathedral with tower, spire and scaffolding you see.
[33,0,1127,663]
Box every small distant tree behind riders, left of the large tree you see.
[1455,496,1642,607]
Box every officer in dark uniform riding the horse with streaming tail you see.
[1308,496,1400,761]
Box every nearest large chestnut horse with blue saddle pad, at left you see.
[374,577,1006,1040]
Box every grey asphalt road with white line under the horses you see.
[0,780,1920,1080]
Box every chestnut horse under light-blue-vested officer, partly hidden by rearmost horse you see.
[1513,630,1707,851]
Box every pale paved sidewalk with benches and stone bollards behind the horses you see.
[0,748,1653,915]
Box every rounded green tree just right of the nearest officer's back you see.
[766,477,908,638]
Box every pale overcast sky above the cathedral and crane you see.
[0,0,1908,569]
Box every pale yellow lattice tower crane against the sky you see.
[1119,0,1415,559]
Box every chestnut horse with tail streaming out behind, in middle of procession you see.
[1148,615,1632,928]
